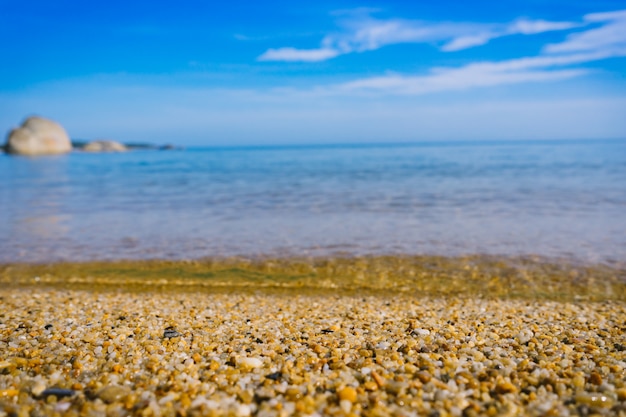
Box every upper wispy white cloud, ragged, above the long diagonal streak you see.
[258,10,580,62]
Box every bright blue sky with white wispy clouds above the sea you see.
[0,0,626,146]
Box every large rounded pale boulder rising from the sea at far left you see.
[6,116,72,156]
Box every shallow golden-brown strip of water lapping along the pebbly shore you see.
[0,252,626,301]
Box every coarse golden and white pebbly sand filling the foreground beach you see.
[0,255,626,416]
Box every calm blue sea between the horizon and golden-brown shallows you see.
[0,141,626,262]
